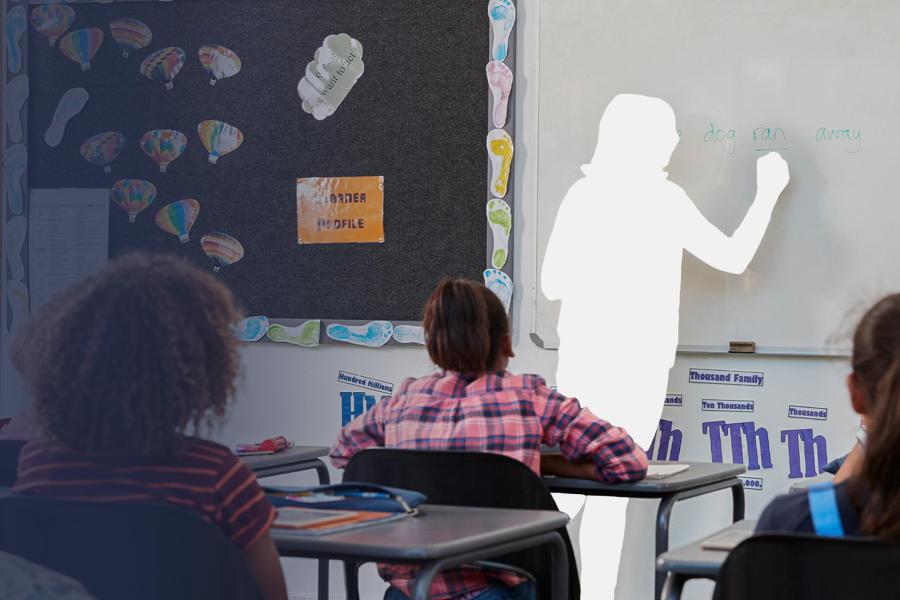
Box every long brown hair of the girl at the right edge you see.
[850,294,900,540]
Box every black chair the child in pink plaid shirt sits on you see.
[344,448,580,600]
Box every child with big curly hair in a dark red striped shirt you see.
[13,254,287,600]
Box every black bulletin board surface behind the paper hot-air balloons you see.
[28,0,500,321]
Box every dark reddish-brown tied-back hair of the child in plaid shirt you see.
[423,278,509,373]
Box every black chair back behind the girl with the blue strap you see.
[714,534,900,600]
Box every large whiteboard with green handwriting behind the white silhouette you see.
[532,0,900,354]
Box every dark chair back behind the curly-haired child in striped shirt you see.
[0,496,261,600]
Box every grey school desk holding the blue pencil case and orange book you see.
[271,504,569,600]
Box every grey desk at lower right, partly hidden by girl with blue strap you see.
[656,519,756,600]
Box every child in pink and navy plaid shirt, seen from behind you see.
[331,279,647,600]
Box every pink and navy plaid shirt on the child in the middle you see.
[331,371,647,600]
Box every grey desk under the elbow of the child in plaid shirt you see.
[544,462,745,598]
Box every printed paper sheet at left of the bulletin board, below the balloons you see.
[28,189,109,310]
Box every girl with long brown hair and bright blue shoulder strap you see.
[756,294,900,540]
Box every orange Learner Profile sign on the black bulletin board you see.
[297,176,384,244]
